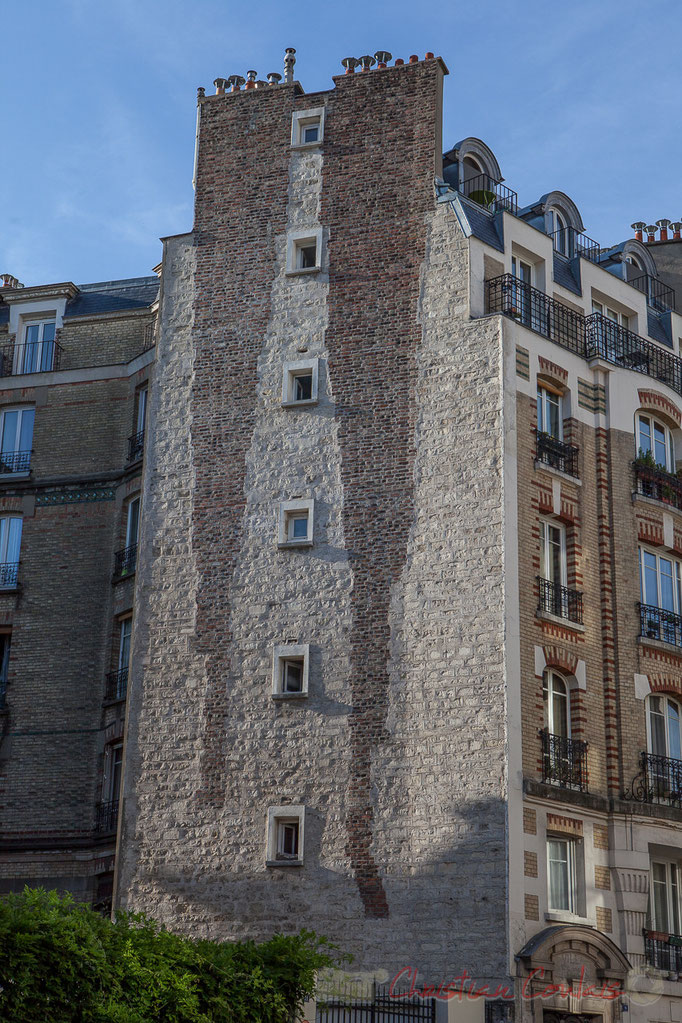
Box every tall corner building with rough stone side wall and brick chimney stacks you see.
[105,48,682,1023]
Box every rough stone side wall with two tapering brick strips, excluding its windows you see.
[120,62,506,980]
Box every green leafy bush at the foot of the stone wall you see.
[0,888,339,1023]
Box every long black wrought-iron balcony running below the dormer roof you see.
[486,273,682,395]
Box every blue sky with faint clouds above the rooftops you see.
[0,0,682,284]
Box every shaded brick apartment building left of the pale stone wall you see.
[0,274,158,907]
